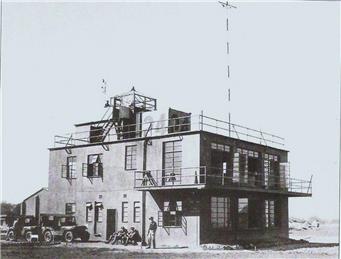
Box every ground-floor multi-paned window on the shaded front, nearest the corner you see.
[211,197,231,228]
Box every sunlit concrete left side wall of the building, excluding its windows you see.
[48,134,200,245]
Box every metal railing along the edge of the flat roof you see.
[54,113,284,147]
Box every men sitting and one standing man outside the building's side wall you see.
[106,217,157,249]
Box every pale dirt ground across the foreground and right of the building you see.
[0,222,339,259]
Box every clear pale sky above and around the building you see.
[1,1,340,219]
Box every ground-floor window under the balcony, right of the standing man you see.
[163,200,182,227]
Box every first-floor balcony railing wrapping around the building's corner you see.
[134,166,312,195]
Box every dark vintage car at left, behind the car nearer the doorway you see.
[7,216,40,241]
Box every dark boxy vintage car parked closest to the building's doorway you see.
[40,214,90,243]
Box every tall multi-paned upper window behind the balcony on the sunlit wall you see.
[162,140,182,185]
